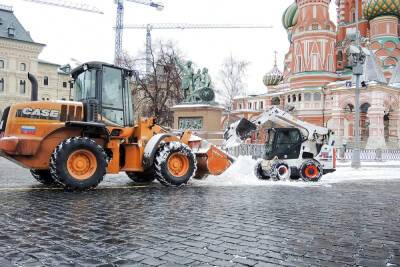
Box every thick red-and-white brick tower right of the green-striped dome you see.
[290,0,337,88]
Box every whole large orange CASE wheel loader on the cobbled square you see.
[0,62,233,190]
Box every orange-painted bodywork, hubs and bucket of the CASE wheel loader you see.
[0,101,232,176]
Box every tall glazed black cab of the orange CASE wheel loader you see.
[71,62,134,127]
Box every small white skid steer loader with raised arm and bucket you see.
[224,107,336,182]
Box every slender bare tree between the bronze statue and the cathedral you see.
[217,54,250,112]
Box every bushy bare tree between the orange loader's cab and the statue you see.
[121,41,183,127]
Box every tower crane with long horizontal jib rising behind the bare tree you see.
[123,23,272,74]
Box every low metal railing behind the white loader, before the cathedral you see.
[226,144,400,161]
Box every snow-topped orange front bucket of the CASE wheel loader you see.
[189,138,235,179]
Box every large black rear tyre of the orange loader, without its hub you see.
[50,137,108,190]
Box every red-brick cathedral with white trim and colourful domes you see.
[231,0,400,149]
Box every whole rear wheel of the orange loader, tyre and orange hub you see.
[50,137,107,190]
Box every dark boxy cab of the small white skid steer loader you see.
[265,128,303,160]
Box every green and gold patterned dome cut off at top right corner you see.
[363,0,400,20]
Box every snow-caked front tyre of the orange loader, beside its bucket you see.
[154,142,197,186]
